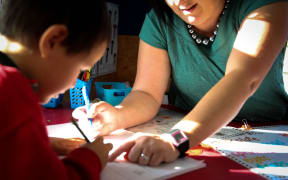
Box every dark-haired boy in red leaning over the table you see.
[0,0,112,180]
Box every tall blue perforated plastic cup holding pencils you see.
[70,79,93,109]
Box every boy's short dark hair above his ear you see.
[0,0,111,54]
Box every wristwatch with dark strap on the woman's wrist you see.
[167,129,189,158]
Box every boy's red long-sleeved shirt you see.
[0,64,101,180]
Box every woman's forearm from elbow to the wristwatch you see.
[174,69,260,147]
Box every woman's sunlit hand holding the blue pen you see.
[72,101,122,135]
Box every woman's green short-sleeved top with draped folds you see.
[140,0,288,121]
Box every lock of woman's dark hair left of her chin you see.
[148,0,173,23]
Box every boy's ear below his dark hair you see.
[39,24,68,58]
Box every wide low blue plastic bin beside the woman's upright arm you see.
[95,82,132,106]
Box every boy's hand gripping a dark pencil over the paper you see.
[83,136,113,169]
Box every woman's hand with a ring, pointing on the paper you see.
[109,133,179,166]
